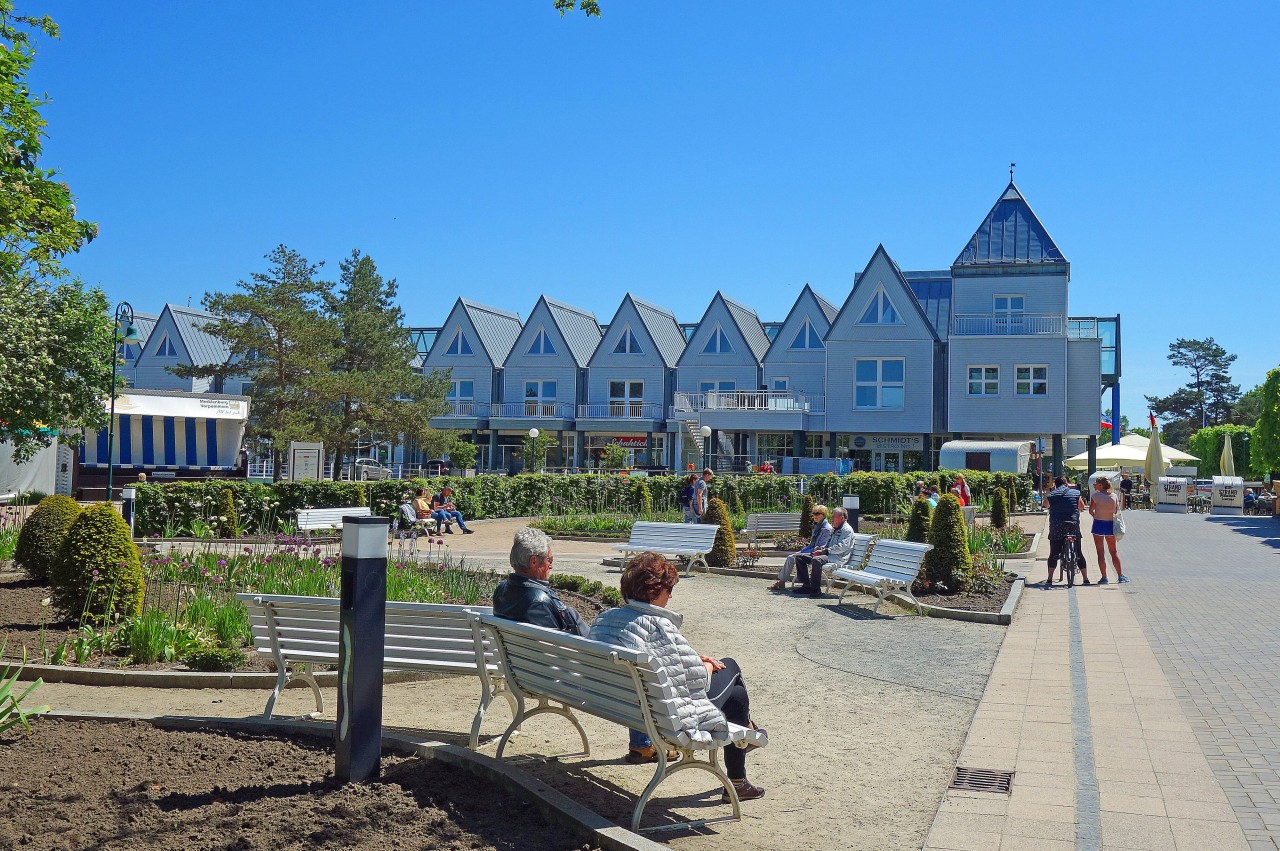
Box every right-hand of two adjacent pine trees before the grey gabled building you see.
[310,251,453,467]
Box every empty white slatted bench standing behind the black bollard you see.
[236,594,516,750]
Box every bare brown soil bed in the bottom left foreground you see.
[0,720,590,851]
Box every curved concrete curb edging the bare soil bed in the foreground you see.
[44,710,669,851]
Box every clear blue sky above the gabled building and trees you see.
[20,0,1280,424]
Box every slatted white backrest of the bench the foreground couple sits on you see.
[472,616,682,738]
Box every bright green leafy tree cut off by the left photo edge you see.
[0,0,114,461]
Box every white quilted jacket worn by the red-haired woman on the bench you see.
[590,600,730,746]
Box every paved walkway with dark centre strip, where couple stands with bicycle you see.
[925,512,1280,851]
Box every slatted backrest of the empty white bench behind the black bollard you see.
[236,594,498,673]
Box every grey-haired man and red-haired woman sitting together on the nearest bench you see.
[493,527,764,801]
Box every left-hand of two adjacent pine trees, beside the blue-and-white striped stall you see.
[170,246,337,479]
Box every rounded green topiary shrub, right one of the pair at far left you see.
[49,503,146,622]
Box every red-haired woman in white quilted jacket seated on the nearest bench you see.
[590,553,764,801]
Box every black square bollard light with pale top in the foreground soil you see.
[334,517,390,783]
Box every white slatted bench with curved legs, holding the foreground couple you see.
[471,616,768,831]
